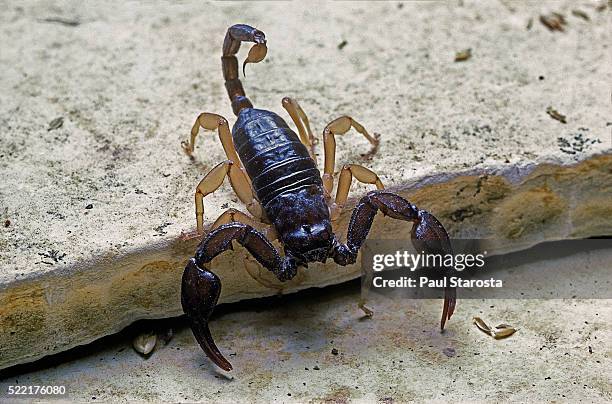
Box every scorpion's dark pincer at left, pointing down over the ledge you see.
[181,258,232,371]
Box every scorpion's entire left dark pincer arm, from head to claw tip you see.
[181,222,297,371]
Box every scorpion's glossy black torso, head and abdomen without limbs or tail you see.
[233,109,333,272]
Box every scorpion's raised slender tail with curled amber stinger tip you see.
[221,24,268,116]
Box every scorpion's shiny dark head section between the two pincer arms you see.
[274,188,336,265]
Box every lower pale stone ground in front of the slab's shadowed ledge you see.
[0,241,612,403]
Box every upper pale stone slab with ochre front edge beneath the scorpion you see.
[0,1,612,368]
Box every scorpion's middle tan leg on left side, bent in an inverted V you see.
[195,160,262,234]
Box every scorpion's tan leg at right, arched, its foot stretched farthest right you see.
[322,116,379,198]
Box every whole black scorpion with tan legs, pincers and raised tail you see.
[181,24,456,370]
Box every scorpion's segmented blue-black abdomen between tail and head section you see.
[232,108,322,208]
